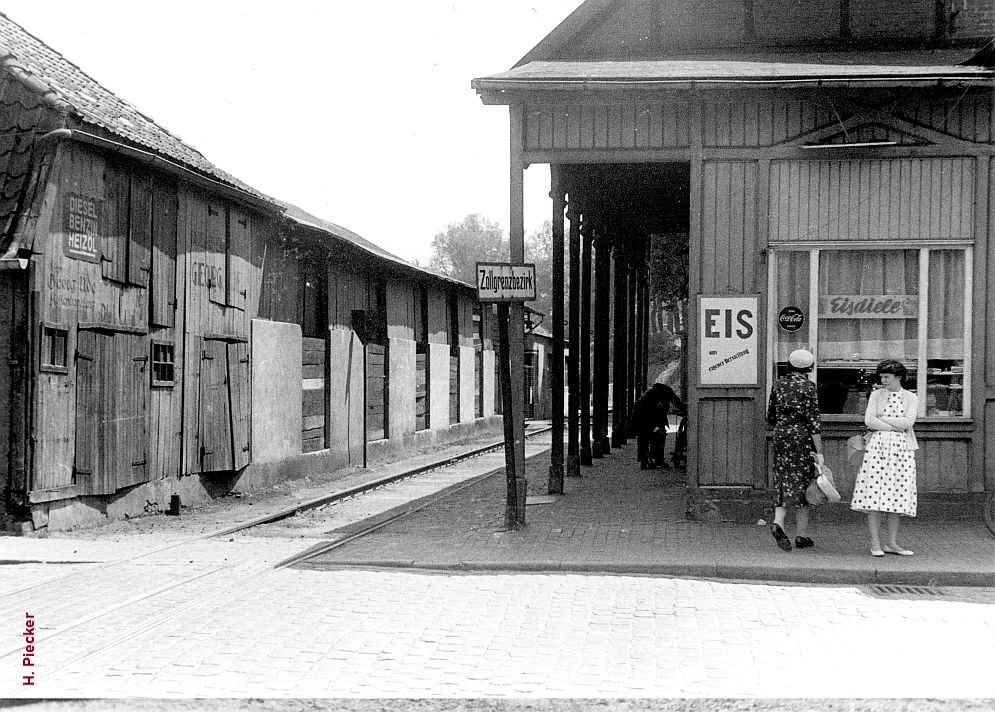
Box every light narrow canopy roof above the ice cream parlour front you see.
[473,50,995,90]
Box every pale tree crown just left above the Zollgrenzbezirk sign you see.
[429,213,508,284]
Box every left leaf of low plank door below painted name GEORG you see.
[197,339,233,472]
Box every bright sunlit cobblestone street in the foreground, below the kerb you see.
[3,562,995,697]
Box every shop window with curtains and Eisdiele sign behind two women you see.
[769,247,972,420]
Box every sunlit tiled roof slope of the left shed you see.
[0,13,269,201]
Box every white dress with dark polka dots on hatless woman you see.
[850,392,917,517]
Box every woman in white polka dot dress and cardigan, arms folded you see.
[850,359,919,556]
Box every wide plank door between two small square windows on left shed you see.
[73,330,149,494]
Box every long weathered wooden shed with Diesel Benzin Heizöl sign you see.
[0,15,500,529]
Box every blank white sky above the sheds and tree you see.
[2,0,581,263]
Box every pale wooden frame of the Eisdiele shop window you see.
[766,240,974,423]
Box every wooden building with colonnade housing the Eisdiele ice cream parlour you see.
[473,0,995,506]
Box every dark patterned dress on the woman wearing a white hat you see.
[767,373,819,507]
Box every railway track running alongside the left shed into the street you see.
[0,428,549,695]
